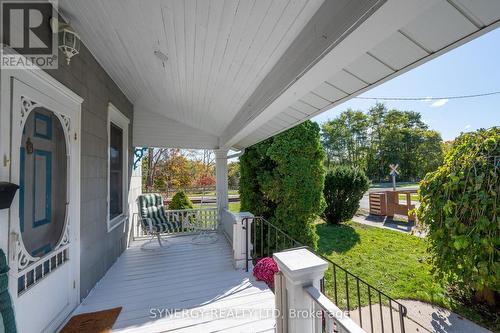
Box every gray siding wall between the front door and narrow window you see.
[47,45,133,298]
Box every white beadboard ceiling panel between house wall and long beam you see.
[59,0,323,144]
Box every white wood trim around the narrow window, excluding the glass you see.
[106,103,130,232]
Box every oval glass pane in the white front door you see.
[19,107,68,257]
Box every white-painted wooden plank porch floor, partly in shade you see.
[75,235,275,333]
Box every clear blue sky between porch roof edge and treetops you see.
[313,28,500,140]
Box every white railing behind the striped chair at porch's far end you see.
[132,208,219,240]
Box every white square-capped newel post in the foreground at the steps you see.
[273,249,328,333]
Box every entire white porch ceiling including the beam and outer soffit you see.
[59,0,500,148]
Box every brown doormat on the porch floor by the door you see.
[60,307,122,333]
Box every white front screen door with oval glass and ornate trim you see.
[2,73,80,333]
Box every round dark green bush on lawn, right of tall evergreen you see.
[323,166,369,224]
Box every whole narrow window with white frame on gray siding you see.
[108,103,130,231]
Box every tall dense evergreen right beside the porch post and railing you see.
[240,121,325,248]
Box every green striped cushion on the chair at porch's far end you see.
[139,193,181,232]
